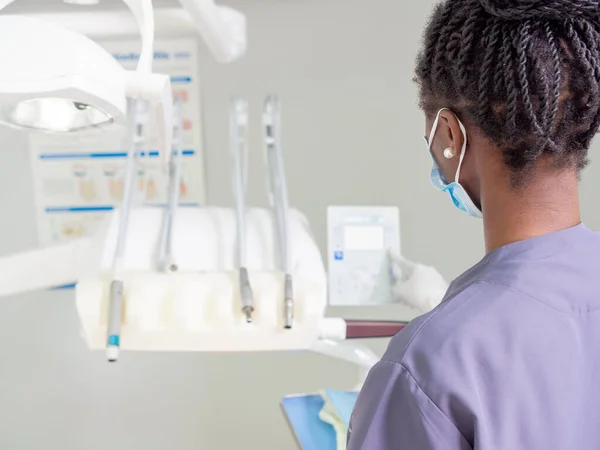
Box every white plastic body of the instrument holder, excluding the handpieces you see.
[76,207,327,351]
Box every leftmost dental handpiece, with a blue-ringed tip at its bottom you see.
[106,101,145,362]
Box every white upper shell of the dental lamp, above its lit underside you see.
[0,16,127,131]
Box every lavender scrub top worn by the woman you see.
[347,224,600,450]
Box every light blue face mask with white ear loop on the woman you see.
[425,108,483,219]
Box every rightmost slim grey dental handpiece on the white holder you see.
[263,96,294,329]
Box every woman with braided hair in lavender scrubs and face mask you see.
[348,0,600,450]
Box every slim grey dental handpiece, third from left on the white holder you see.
[230,97,254,323]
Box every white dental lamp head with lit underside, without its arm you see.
[0,16,127,133]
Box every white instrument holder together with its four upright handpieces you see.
[76,94,327,359]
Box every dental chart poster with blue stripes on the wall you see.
[29,38,206,245]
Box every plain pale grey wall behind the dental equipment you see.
[0,0,600,450]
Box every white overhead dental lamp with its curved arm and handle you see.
[0,0,173,160]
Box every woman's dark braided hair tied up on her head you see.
[416,0,600,183]
